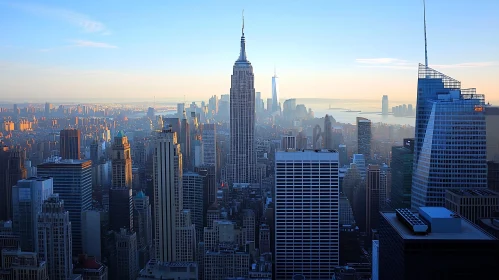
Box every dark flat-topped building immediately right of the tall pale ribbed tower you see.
[182,172,204,241]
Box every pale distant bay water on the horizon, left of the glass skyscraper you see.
[296,98,416,126]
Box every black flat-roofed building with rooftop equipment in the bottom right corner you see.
[378,207,499,280]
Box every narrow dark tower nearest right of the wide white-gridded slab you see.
[366,165,381,236]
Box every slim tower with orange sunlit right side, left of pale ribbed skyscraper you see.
[112,131,132,189]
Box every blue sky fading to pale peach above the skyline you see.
[0,0,499,102]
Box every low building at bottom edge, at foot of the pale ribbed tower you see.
[137,259,199,280]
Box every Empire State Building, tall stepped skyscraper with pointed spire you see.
[228,16,256,186]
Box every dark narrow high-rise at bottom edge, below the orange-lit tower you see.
[114,228,140,280]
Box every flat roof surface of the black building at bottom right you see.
[381,207,495,240]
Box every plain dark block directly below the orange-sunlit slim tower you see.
[109,187,133,232]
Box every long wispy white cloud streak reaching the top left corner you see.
[10,2,110,34]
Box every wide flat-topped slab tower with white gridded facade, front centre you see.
[276,150,339,279]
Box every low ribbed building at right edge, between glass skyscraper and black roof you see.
[445,189,499,223]
